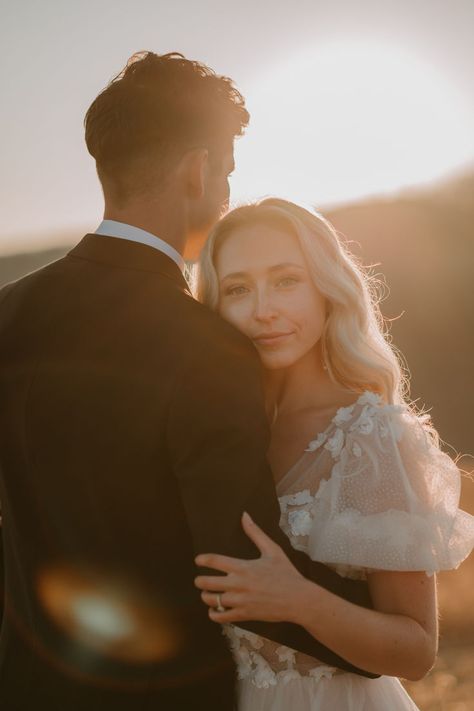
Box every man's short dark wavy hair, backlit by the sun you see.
[84,52,249,203]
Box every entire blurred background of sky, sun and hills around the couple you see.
[0,0,474,711]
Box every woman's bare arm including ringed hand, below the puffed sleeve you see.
[196,516,438,680]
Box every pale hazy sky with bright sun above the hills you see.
[0,0,474,253]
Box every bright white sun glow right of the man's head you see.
[232,42,474,204]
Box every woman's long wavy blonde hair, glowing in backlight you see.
[194,198,408,404]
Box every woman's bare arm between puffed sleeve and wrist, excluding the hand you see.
[288,571,438,681]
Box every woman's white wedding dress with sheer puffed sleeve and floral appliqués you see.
[224,392,474,711]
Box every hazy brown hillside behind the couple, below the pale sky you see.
[0,173,474,453]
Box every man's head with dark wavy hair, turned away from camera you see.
[84,52,249,252]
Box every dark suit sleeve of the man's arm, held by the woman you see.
[168,324,375,676]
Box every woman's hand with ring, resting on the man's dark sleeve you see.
[195,513,306,623]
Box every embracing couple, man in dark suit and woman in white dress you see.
[0,52,474,711]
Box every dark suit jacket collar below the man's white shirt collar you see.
[68,234,189,291]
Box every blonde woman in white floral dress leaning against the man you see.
[196,199,474,711]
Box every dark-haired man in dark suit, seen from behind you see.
[0,52,378,711]
